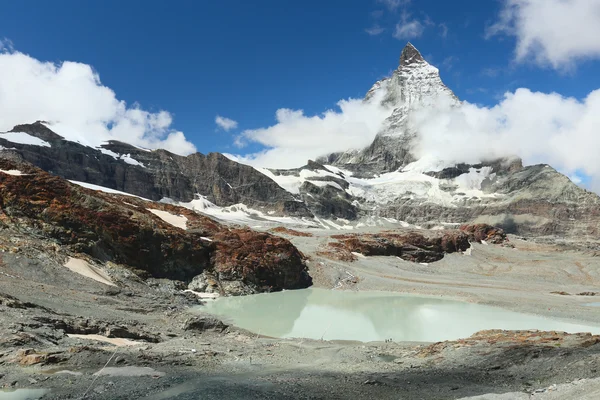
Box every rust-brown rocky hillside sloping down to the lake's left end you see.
[0,159,311,294]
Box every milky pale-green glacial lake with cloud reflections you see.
[198,289,600,342]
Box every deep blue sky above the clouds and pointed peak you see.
[0,0,600,184]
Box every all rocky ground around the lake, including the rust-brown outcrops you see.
[0,160,600,399]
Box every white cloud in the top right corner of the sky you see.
[487,0,600,69]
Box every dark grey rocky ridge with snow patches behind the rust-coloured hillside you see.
[0,122,312,216]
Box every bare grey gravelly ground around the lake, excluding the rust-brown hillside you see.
[0,230,600,399]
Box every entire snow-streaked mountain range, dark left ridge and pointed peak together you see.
[0,43,600,242]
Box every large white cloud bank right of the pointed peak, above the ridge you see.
[410,89,600,189]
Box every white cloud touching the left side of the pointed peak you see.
[227,93,391,168]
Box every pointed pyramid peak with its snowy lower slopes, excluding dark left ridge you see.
[269,43,600,242]
